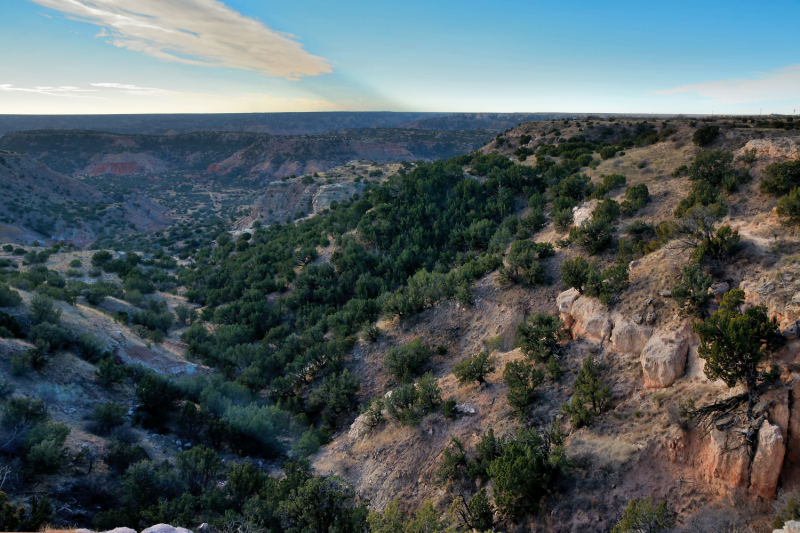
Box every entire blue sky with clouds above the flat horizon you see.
[0,0,800,114]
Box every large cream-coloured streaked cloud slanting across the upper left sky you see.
[31,0,332,80]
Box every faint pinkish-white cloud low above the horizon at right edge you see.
[656,65,800,104]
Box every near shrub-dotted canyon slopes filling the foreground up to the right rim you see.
[0,117,800,533]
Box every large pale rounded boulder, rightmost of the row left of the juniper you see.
[641,323,691,389]
